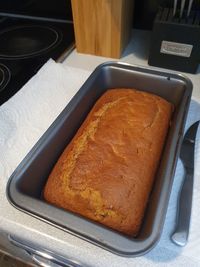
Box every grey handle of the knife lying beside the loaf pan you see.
[171,169,194,247]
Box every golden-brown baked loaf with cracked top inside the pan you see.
[44,88,173,236]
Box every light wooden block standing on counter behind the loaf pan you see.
[71,0,134,58]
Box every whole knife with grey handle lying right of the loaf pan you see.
[171,121,200,247]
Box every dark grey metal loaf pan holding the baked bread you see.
[7,62,192,256]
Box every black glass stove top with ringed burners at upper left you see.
[0,16,75,105]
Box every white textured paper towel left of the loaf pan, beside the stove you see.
[0,59,90,181]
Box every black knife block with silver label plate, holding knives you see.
[148,8,200,73]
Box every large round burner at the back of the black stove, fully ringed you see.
[0,26,62,59]
